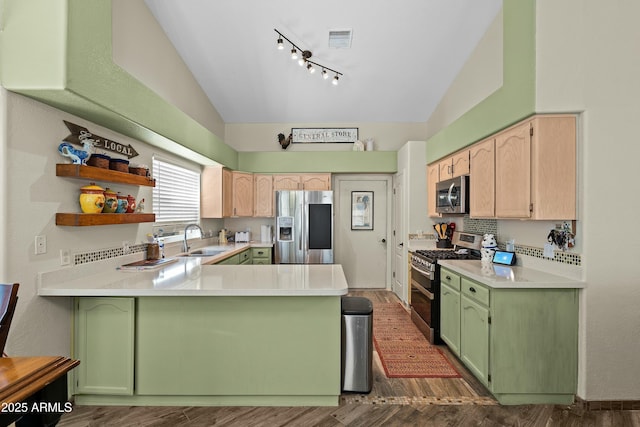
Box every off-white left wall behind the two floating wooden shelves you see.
[0,89,219,355]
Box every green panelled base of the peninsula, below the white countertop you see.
[74,296,341,406]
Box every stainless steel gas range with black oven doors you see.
[410,231,482,344]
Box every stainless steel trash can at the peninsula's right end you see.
[342,297,373,393]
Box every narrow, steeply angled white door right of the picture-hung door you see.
[391,172,408,302]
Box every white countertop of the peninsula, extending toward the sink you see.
[38,244,348,296]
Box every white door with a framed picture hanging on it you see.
[334,176,390,289]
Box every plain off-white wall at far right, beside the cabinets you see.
[536,0,640,400]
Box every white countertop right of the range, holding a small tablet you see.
[438,260,586,289]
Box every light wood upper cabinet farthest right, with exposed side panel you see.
[495,115,576,220]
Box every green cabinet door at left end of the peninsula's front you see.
[73,297,135,395]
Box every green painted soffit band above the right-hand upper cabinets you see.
[427,0,536,163]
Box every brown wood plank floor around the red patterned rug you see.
[58,291,640,427]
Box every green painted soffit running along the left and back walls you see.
[0,0,396,173]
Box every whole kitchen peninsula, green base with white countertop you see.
[38,257,347,406]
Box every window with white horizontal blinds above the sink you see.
[152,157,200,222]
